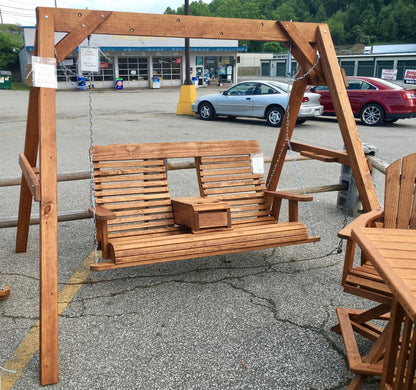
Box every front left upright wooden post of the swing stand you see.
[37,8,59,385]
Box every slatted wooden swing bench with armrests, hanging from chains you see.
[91,141,319,270]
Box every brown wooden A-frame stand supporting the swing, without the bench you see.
[16,8,379,385]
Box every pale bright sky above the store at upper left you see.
[0,0,197,26]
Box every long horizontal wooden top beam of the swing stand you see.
[44,8,317,43]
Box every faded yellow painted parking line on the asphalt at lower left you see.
[0,252,94,390]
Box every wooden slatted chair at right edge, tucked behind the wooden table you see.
[333,153,416,389]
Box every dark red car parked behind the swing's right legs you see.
[308,77,416,126]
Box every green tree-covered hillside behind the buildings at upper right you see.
[165,0,416,52]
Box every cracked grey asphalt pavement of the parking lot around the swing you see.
[0,88,416,390]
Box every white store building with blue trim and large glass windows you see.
[20,27,247,89]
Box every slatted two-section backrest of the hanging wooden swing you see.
[93,141,264,239]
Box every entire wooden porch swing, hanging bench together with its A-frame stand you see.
[16,8,379,385]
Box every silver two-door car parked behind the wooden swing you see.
[192,80,323,127]
